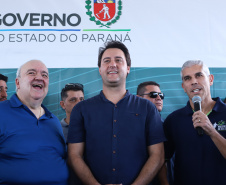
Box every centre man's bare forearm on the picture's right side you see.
[132,143,164,185]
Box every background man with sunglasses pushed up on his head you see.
[60,83,84,140]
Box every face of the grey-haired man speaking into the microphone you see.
[182,65,214,102]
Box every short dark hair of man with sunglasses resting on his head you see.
[61,83,84,101]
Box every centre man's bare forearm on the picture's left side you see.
[68,143,100,185]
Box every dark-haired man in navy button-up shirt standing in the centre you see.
[68,41,165,185]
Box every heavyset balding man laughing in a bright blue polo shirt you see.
[0,60,68,185]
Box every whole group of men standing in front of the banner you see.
[0,41,226,185]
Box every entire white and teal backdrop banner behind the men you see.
[0,0,226,119]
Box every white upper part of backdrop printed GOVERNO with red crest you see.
[0,0,226,68]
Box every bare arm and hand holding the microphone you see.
[192,111,226,159]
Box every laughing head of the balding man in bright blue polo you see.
[16,60,49,104]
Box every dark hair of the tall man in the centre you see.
[98,41,131,67]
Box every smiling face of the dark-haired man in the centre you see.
[99,48,130,87]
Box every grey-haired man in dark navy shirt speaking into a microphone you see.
[164,60,226,185]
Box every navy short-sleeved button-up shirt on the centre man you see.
[68,91,165,185]
